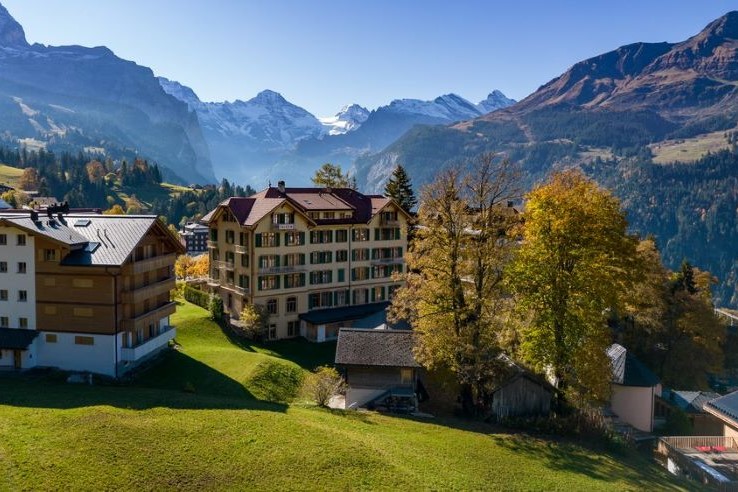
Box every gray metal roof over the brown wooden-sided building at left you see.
[62,214,156,266]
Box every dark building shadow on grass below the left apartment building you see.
[0,351,287,412]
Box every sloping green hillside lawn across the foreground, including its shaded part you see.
[0,304,681,490]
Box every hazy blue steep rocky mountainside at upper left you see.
[0,2,215,182]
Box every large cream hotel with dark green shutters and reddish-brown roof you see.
[203,182,409,341]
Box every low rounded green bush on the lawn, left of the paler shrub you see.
[247,361,304,403]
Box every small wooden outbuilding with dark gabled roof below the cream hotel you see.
[336,328,420,412]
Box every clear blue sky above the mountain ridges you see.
[0,0,738,116]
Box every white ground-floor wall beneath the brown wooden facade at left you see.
[35,332,123,377]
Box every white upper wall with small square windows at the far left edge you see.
[0,226,36,330]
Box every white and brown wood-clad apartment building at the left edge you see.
[0,207,184,377]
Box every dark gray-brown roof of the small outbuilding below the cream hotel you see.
[336,328,420,367]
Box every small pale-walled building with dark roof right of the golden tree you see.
[607,343,661,432]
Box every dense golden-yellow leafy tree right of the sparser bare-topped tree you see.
[509,170,637,405]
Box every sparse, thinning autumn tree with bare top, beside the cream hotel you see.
[391,154,519,414]
